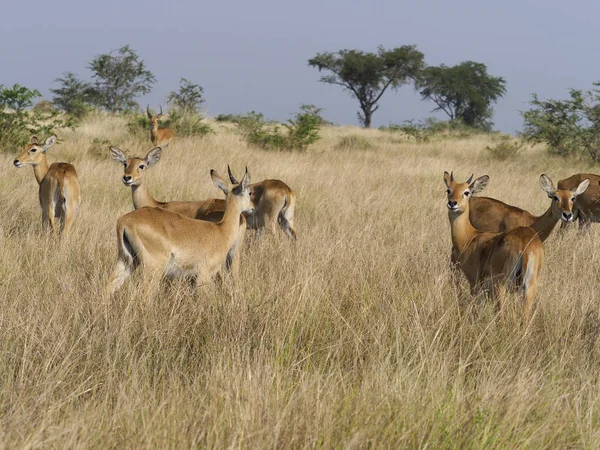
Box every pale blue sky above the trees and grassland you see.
[0,0,600,132]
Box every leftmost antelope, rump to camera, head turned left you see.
[14,136,81,234]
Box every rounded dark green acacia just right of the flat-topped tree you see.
[417,61,506,129]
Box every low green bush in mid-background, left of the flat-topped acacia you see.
[233,111,320,151]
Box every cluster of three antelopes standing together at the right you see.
[444,172,600,324]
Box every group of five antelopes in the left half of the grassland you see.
[14,108,296,295]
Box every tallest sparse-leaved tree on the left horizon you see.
[88,45,156,113]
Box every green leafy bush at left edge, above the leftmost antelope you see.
[0,84,70,151]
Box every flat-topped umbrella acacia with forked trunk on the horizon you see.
[308,45,424,128]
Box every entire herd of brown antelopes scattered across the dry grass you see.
[14,107,600,324]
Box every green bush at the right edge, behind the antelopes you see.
[521,83,600,160]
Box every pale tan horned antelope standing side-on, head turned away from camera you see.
[107,170,252,294]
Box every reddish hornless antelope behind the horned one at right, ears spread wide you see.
[451,174,590,264]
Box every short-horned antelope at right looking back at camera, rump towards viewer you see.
[444,172,544,324]
